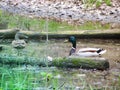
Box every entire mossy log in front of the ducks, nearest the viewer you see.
[0,54,109,70]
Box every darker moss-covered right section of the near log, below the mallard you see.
[52,58,109,69]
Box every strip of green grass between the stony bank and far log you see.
[0,11,109,32]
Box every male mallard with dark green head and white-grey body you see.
[69,36,106,57]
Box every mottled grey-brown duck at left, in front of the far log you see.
[12,31,28,49]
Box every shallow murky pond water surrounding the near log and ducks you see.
[0,39,120,90]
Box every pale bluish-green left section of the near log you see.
[0,54,45,66]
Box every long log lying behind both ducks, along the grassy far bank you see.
[0,29,120,40]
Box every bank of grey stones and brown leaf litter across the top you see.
[0,0,120,24]
